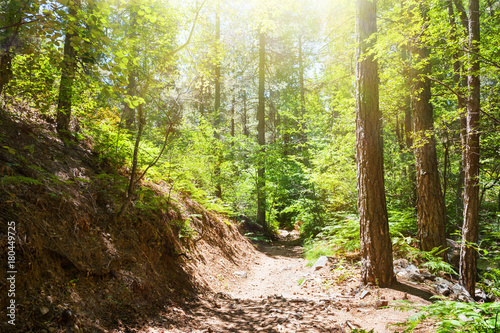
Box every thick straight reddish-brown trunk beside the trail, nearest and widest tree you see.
[356,0,395,286]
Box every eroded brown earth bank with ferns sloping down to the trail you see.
[0,105,254,332]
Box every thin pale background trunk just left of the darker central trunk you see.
[214,3,222,198]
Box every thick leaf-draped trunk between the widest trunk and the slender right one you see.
[411,9,446,259]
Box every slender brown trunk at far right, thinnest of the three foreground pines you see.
[460,0,481,297]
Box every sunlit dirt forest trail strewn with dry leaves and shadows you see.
[139,232,432,333]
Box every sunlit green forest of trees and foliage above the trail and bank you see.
[0,0,500,332]
